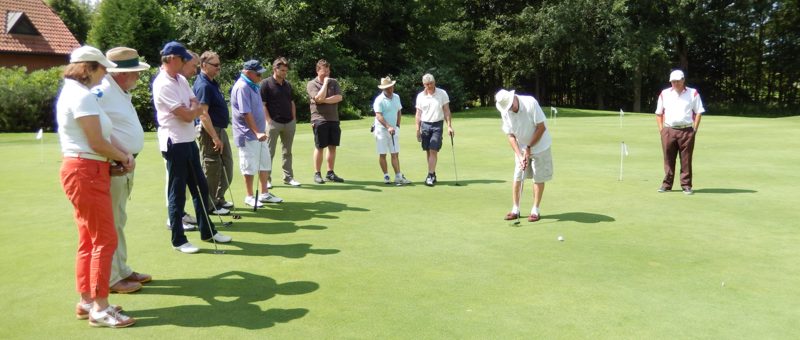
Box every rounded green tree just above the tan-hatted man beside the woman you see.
[89,0,174,65]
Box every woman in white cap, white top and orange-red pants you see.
[56,46,135,328]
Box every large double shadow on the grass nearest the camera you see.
[127,271,319,329]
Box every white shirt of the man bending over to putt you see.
[500,95,553,153]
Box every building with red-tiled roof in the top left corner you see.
[0,0,80,71]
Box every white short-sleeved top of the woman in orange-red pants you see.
[56,79,113,154]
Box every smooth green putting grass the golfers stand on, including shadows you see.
[0,107,800,339]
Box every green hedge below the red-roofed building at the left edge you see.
[0,67,63,132]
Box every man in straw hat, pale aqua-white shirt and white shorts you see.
[372,77,411,186]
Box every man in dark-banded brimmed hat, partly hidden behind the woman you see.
[97,47,152,293]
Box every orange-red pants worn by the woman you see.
[61,157,117,298]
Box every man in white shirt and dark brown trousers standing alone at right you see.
[656,70,706,195]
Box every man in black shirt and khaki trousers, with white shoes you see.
[260,57,300,187]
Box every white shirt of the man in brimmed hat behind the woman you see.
[97,74,144,153]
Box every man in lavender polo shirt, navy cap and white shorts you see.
[231,60,283,209]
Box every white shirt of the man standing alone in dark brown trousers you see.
[656,87,706,126]
